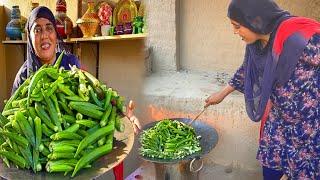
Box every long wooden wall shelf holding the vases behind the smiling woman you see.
[2,34,147,44]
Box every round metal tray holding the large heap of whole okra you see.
[0,118,134,180]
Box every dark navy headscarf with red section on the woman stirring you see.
[228,0,317,121]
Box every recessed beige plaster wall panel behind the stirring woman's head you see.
[180,0,320,71]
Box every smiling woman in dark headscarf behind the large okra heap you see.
[12,6,141,180]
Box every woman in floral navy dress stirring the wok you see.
[205,0,320,180]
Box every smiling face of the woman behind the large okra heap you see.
[30,18,57,64]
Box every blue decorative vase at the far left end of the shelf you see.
[6,6,21,40]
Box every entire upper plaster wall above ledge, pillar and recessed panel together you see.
[147,0,320,72]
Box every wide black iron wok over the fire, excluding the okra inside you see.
[139,118,218,163]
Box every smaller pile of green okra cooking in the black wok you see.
[140,119,201,160]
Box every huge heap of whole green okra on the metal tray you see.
[0,53,125,177]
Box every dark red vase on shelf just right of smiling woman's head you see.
[55,0,73,38]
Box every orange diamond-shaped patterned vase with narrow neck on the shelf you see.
[76,0,100,37]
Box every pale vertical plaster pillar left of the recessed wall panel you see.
[144,0,179,72]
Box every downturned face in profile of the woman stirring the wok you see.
[231,20,260,44]
